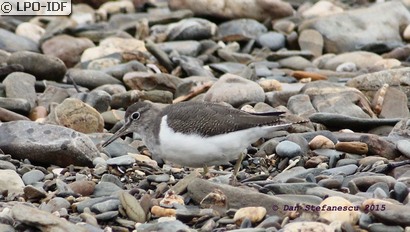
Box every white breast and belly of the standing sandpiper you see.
[159,116,292,167]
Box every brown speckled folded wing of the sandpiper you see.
[161,102,283,137]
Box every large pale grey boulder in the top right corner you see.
[299,2,410,53]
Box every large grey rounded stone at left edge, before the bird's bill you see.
[0,121,99,167]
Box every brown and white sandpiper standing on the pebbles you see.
[102,101,306,177]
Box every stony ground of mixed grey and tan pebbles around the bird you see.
[0,0,410,232]
